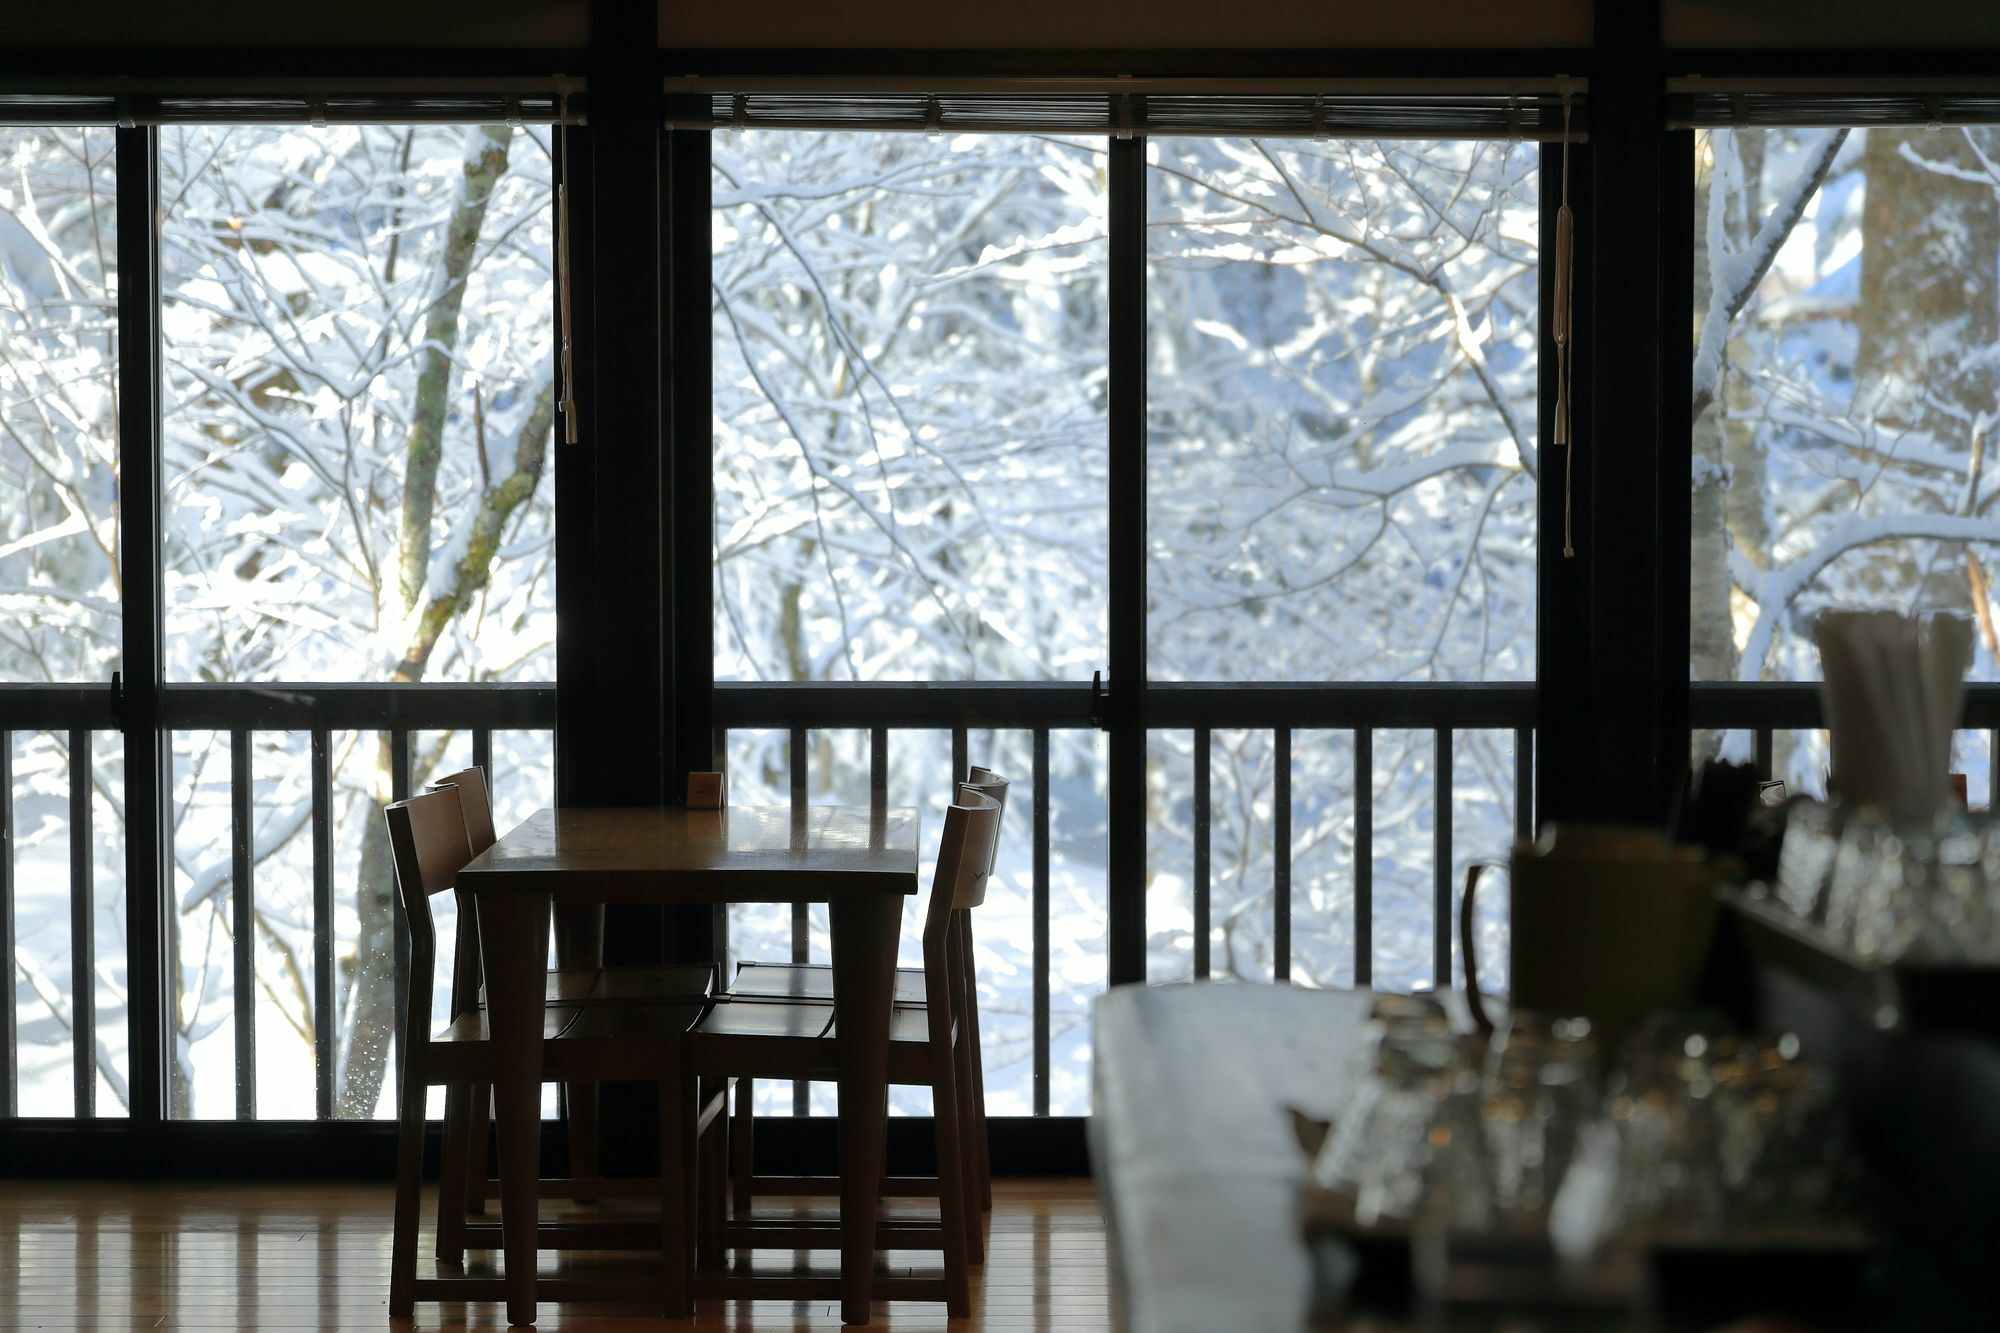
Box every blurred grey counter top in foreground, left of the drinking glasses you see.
[1090,983,1372,1333]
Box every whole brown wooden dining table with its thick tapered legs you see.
[458,805,918,1323]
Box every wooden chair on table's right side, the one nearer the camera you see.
[682,785,1000,1317]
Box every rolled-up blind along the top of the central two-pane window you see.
[668,90,1588,142]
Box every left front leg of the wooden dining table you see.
[476,893,548,1323]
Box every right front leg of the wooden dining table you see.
[828,893,902,1323]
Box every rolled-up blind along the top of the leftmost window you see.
[0,84,586,126]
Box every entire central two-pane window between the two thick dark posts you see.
[712,128,1542,1113]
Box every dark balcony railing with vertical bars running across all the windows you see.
[11,683,2000,1119]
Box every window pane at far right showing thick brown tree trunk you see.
[1690,126,2000,688]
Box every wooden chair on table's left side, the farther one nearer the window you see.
[424,765,714,1224]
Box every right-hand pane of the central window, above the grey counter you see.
[1146,138,1554,989]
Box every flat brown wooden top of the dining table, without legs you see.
[458,805,918,903]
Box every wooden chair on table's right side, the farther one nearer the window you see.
[726,767,1008,1240]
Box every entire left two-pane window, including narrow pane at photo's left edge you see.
[0,124,556,1119]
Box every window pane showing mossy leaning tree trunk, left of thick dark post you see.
[160,126,556,1119]
